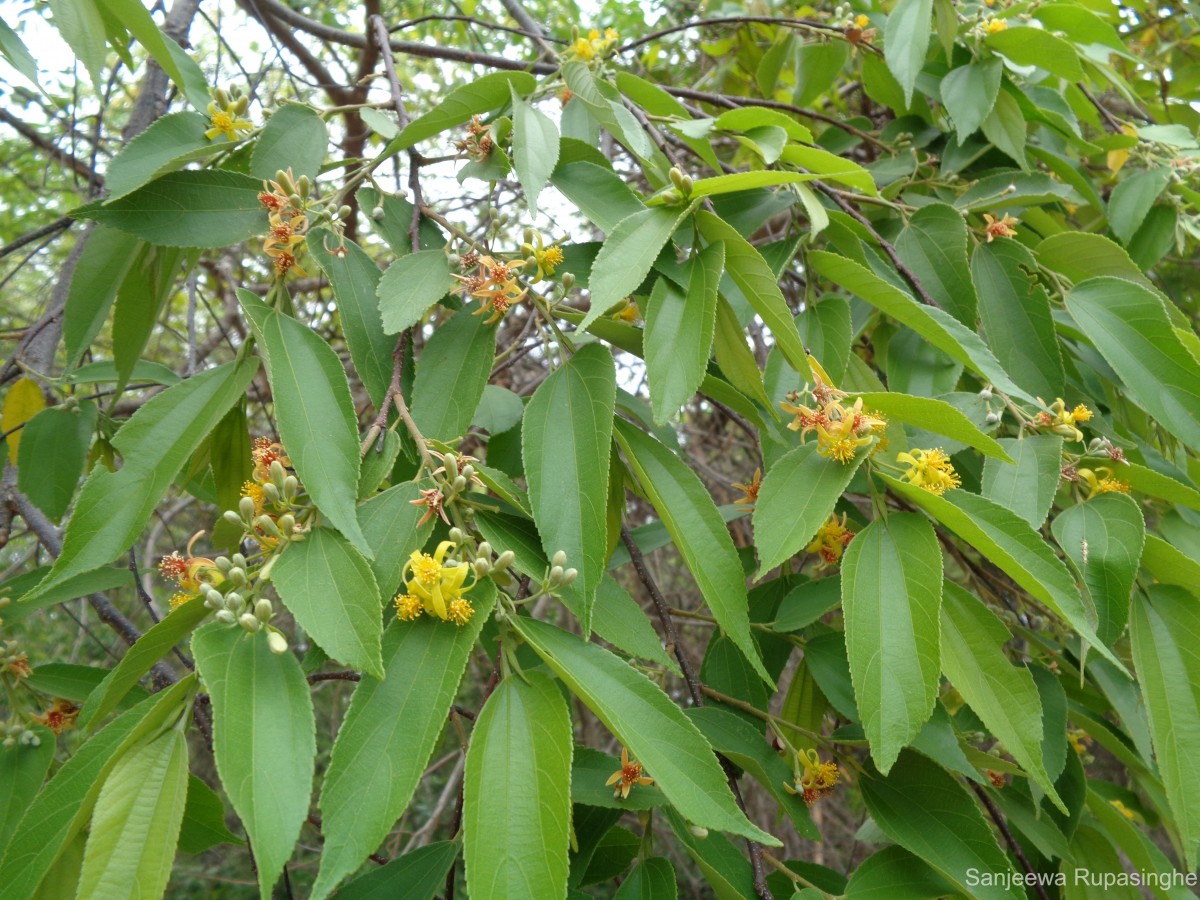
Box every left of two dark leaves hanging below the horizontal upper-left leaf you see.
[62,226,144,368]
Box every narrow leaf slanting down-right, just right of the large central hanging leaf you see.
[614,419,774,681]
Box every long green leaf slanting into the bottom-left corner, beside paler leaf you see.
[0,676,196,896]
